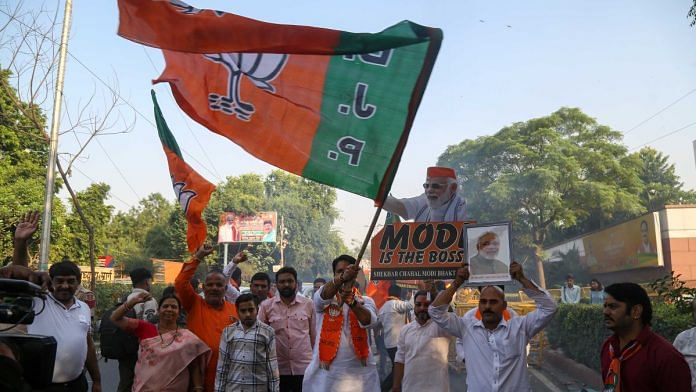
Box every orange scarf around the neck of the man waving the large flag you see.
[319,288,370,370]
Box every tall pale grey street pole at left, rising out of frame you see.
[39,0,73,272]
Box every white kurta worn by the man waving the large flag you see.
[302,286,380,392]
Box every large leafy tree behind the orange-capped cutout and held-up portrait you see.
[438,108,641,284]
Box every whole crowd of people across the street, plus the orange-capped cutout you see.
[0,168,696,392]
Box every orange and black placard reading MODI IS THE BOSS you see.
[370,222,472,280]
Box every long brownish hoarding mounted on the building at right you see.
[544,212,664,274]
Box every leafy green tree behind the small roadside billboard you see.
[198,170,345,279]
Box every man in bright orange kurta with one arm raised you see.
[174,244,239,392]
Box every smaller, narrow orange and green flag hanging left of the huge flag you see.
[152,91,215,253]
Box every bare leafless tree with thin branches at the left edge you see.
[0,2,135,290]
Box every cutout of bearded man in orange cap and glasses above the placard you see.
[384,166,466,222]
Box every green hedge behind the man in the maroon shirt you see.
[546,303,693,370]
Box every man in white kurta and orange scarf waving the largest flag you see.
[302,255,379,392]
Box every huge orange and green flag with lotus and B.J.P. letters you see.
[118,0,442,204]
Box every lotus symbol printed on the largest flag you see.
[204,53,288,121]
